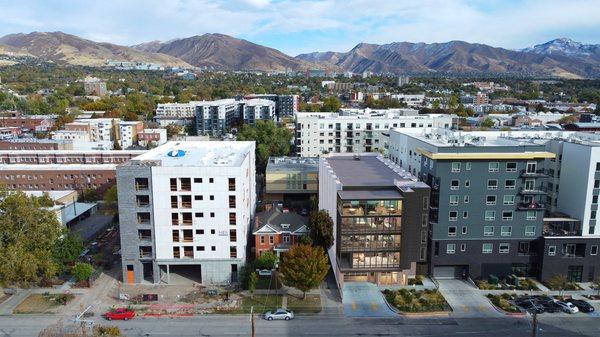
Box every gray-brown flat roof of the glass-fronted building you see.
[325,153,417,187]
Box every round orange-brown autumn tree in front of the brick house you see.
[279,245,329,298]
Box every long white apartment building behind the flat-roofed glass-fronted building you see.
[296,109,457,157]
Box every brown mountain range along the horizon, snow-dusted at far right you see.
[0,32,600,78]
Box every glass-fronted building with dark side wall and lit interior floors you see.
[319,153,430,289]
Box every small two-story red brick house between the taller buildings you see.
[252,207,308,258]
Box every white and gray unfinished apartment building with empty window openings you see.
[117,141,256,284]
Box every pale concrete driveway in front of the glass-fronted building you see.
[342,282,398,317]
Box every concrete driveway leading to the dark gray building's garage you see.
[437,279,504,317]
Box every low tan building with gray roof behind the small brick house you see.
[265,157,319,208]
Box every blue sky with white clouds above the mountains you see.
[0,0,600,56]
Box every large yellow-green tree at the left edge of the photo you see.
[0,191,62,286]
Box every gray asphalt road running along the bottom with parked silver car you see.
[0,314,600,337]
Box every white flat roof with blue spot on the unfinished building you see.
[132,141,254,167]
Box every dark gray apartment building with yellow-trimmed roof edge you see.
[389,128,555,279]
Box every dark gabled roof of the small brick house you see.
[252,207,308,234]
